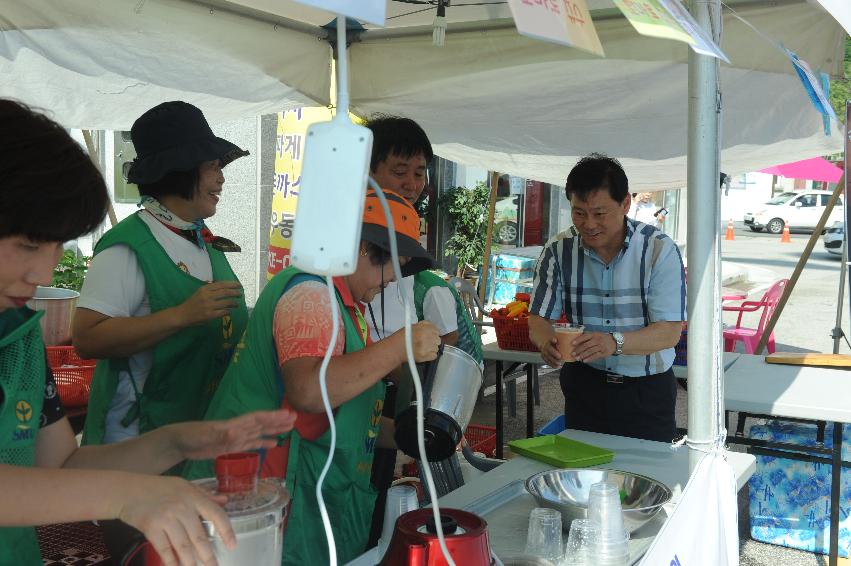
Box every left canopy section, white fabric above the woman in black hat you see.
[0,0,330,130]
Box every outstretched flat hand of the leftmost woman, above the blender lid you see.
[171,409,296,460]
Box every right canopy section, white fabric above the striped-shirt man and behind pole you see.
[352,4,845,190]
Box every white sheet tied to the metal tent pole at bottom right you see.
[639,451,739,566]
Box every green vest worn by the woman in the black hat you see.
[83,214,248,444]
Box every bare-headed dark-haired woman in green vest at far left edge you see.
[0,99,294,566]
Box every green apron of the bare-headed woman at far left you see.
[0,308,46,566]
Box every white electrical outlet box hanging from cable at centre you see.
[290,119,372,276]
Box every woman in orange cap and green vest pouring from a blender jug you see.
[188,191,440,566]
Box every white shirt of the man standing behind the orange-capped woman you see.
[366,275,458,340]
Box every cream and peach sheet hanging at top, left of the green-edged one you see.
[508,0,605,57]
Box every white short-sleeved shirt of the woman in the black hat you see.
[77,211,213,444]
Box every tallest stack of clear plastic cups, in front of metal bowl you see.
[588,482,629,566]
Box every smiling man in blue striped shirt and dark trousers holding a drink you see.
[529,154,686,442]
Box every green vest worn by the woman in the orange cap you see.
[184,267,384,566]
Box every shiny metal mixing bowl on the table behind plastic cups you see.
[526,469,673,533]
